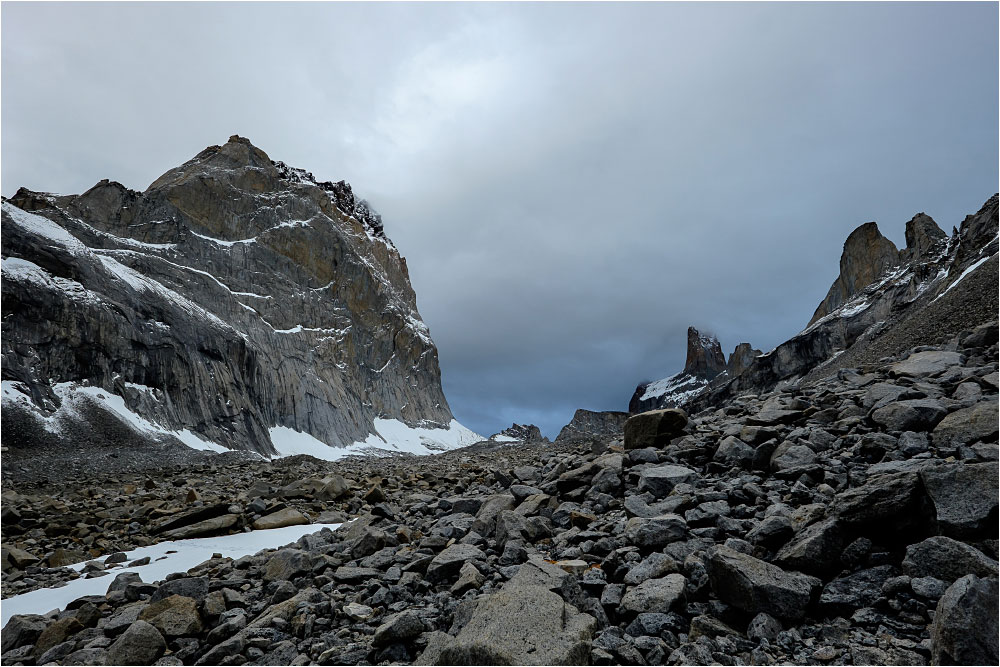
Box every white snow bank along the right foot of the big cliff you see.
[270,419,486,461]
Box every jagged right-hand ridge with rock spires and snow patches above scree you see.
[690,195,998,409]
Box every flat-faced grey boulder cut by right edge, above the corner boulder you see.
[920,463,1000,538]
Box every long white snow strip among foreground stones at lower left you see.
[0,523,340,625]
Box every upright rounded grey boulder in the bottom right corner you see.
[930,574,1000,665]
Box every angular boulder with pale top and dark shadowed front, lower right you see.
[707,547,821,619]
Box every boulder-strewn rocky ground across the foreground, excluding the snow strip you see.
[0,324,998,665]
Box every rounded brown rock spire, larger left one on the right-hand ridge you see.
[809,222,899,324]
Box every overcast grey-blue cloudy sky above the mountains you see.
[0,2,998,437]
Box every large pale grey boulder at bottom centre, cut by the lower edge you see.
[416,585,597,665]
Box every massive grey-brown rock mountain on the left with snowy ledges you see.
[2,136,482,458]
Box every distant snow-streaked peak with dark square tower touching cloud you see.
[628,327,760,414]
